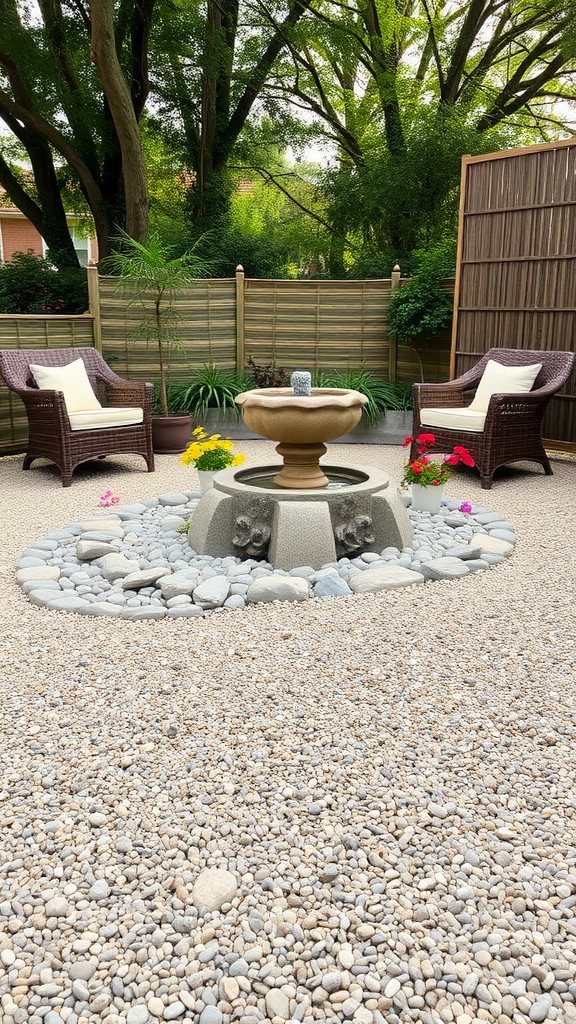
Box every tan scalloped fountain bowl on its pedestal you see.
[236,387,368,490]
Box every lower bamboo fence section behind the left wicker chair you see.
[0,313,93,455]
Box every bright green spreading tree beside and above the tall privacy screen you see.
[268,0,576,260]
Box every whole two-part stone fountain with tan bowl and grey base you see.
[189,374,412,569]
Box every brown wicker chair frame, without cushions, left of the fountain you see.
[0,348,154,487]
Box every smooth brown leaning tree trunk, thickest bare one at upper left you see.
[90,0,149,242]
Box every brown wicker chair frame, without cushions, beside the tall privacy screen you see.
[410,348,574,489]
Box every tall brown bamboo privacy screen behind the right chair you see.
[451,139,576,447]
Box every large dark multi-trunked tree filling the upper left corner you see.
[0,0,155,264]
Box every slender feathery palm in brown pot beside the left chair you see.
[105,231,213,455]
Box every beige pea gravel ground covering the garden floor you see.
[0,441,576,1024]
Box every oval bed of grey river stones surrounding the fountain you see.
[16,492,516,620]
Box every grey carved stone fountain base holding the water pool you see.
[188,463,412,569]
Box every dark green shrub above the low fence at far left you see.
[0,253,88,314]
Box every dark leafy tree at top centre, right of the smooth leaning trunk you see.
[146,0,311,230]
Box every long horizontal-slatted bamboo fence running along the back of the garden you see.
[0,271,452,454]
